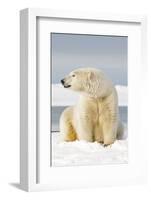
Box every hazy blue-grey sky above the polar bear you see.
[50,33,128,85]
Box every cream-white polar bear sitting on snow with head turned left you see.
[60,68,123,146]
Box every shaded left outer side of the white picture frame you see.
[20,9,28,191]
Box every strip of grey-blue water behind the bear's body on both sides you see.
[51,106,128,132]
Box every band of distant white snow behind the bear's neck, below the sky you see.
[52,84,128,106]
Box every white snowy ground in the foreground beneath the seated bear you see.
[52,124,128,167]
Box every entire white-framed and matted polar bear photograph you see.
[20,9,147,191]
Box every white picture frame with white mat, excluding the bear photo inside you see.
[20,8,147,191]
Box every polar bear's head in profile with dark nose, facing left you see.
[61,68,113,97]
